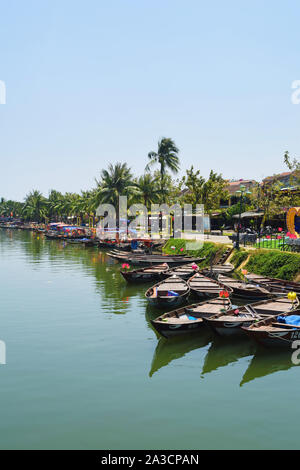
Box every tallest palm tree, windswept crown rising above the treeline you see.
[146,137,179,193]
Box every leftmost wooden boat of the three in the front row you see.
[151,298,231,338]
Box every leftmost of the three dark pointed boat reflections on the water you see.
[149,329,212,377]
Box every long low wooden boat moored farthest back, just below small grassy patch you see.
[107,250,205,267]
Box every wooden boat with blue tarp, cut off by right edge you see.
[242,310,300,346]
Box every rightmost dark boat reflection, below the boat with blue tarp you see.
[240,347,297,387]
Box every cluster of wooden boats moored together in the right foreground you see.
[121,263,300,347]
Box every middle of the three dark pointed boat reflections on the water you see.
[201,336,256,377]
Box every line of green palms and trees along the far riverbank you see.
[0,141,300,228]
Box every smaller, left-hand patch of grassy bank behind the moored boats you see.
[163,238,227,267]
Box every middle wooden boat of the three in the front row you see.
[204,297,299,336]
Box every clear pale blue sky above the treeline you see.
[0,0,300,200]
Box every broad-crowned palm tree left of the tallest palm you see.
[96,162,139,228]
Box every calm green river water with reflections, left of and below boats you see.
[0,230,300,449]
